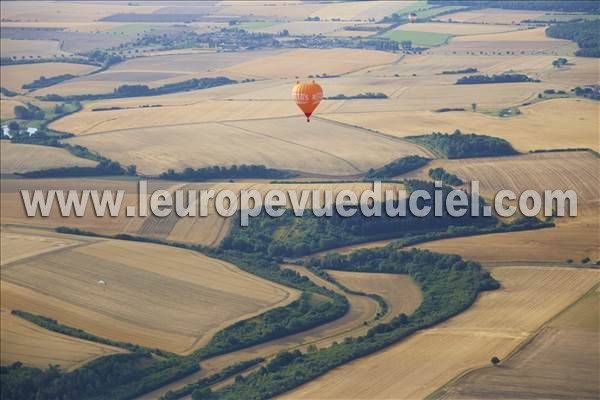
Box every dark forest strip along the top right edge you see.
[428,0,599,13]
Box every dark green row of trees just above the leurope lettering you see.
[160,164,296,182]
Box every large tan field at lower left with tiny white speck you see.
[2,230,298,353]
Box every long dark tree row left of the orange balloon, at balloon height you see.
[40,76,237,101]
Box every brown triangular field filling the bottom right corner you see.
[435,290,600,399]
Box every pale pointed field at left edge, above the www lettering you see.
[0,141,97,174]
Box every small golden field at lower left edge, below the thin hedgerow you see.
[0,310,124,370]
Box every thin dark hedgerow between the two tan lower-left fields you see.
[11,310,174,357]
